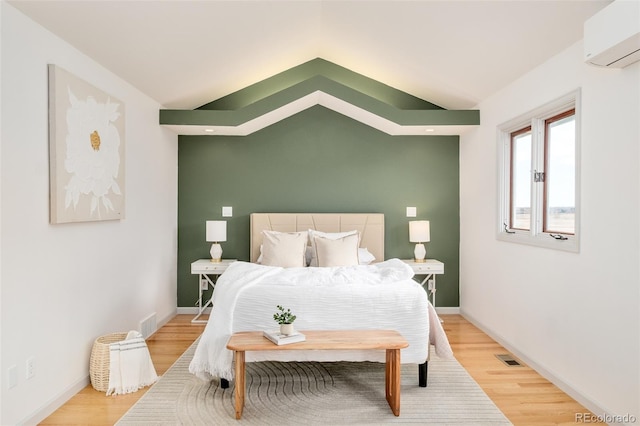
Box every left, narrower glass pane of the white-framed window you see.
[509,128,531,230]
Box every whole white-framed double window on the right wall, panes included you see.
[498,88,580,251]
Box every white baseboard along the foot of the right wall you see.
[460,309,611,417]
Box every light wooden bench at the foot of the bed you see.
[227,330,409,419]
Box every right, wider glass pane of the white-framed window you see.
[544,111,576,234]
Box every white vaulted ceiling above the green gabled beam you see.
[9,0,610,113]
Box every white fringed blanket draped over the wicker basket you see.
[107,330,158,395]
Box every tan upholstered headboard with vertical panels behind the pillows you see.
[251,213,384,262]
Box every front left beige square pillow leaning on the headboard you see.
[261,231,308,268]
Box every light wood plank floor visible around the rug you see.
[40,315,600,425]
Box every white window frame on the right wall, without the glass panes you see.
[497,89,582,253]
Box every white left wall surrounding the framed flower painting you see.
[0,1,177,425]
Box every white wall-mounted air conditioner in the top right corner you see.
[584,0,640,68]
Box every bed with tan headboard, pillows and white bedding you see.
[189,213,452,386]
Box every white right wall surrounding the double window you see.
[460,42,640,419]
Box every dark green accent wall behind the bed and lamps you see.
[178,106,460,307]
